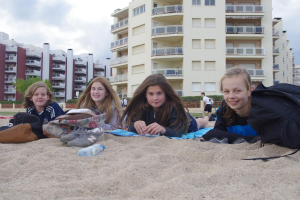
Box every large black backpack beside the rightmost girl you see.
[248,83,300,149]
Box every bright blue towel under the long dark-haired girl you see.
[109,127,213,140]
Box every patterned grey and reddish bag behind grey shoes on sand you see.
[43,109,106,138]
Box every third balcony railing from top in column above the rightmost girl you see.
[226,47,265,56]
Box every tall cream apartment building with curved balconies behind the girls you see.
[110,0,292,97]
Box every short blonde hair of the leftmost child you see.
[22,81,53,108]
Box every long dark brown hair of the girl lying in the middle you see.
[120,74,189,134]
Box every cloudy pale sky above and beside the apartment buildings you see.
[0,0,300,64]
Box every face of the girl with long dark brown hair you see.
[146,85,166,110]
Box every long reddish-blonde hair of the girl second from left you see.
[75,76,122,123]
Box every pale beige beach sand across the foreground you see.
[0,116,300,199]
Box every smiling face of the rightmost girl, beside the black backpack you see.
[222,74,254,116]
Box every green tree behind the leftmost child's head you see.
[12,77,53,95]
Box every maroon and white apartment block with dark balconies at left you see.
[0,34,106,102]
